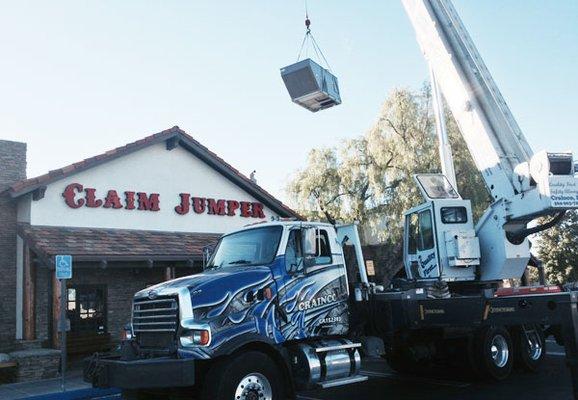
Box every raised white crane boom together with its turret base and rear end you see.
[402,0,578,280]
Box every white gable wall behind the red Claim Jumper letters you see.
[27,143,277,233]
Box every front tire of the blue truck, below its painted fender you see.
[201,351,286,400]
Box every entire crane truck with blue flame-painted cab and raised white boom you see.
[85,0,578,400]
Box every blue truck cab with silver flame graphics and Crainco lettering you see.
[85,221,366,399]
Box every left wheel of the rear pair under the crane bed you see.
[469,326,513,381]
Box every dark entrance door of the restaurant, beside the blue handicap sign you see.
[66,285,110,354]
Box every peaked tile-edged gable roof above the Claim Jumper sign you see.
[8,126,303,219]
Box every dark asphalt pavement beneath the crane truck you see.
[92,340,573,400]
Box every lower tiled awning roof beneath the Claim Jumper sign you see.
[18,223,220,261]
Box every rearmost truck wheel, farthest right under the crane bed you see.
[514,325,546,372]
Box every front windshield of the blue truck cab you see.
[207,226,283,268]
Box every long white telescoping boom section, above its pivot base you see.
[402,0,533,199]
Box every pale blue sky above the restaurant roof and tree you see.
[0,0,578,201]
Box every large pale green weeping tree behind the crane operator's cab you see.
[287,86,488,243]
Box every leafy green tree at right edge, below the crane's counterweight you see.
[538,211,578,284]
